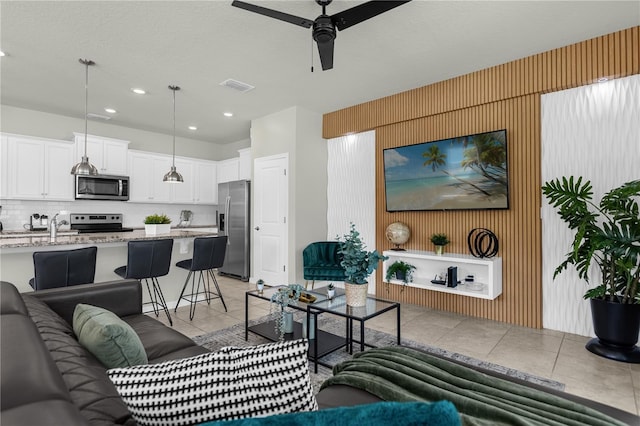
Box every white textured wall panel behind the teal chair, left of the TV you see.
[327,131,376,294]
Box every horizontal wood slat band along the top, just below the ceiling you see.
[322,26,640,139]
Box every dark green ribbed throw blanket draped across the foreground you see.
[322,347,624,426]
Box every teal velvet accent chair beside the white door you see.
[302,241,346,289]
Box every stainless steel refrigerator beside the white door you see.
[218,180,251,281]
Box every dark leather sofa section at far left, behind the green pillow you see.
[0,280,208,426]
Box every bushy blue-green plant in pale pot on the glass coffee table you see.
[336,223,387,307]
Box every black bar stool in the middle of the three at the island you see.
[113,238,173,326]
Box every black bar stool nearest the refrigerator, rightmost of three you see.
[173,236,227,320]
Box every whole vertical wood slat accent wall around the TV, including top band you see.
[323,27,640,328]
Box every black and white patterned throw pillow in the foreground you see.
[107,340,318,426]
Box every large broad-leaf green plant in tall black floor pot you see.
[542,176,640,363]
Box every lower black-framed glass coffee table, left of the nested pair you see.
[244,286,347,372]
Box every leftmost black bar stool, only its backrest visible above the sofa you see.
[29,246,98,290]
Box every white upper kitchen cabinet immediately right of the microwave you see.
[129,150,172,203]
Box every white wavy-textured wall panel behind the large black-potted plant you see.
[541,75,640,336]
